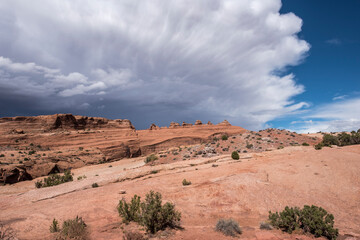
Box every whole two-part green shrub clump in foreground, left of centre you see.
[118,191,181,233]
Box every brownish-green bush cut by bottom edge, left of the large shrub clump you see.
[59,216,88,240]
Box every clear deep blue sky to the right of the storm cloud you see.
[269,0,360,130]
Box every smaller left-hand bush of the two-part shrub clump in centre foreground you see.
[117,195,141,223]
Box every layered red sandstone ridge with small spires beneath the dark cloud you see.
[0,114,245,183]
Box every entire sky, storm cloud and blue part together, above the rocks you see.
[0,0,360,132]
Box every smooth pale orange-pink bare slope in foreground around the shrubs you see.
[0,146,360,240]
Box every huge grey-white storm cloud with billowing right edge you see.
[0,0,309,129]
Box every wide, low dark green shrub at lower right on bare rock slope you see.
[269,205,338,240]
